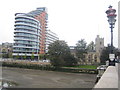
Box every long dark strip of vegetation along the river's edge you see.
[2,62,97,74]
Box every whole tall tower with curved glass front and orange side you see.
[13,7,56,58]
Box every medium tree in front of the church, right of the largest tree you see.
[75,39,87,61]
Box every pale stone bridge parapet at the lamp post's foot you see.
[94,66,118,89]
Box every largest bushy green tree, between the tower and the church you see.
[48,40,77,67]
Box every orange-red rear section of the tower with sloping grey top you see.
[28,7,48,54]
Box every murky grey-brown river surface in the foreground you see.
[2,67,96,88]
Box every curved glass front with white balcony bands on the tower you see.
[13,14,40,56]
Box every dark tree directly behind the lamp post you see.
[100,44,118,64]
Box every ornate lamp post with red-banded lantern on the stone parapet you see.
[106,5,117,66]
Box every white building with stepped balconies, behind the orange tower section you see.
[46,30,59,52]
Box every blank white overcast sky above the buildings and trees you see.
[0,0,119,47]
